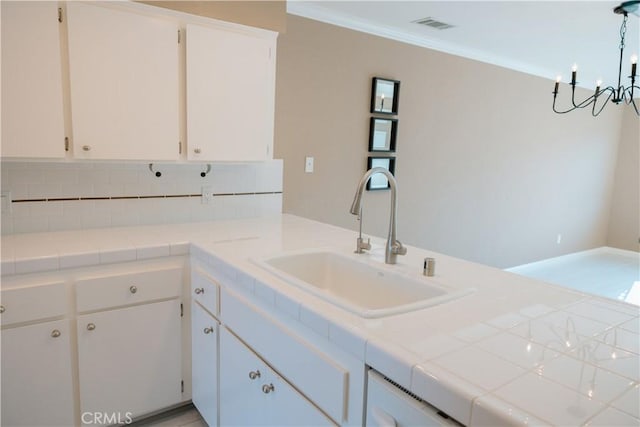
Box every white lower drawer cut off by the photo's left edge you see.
[1,282,67,326]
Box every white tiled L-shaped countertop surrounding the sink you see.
[1,215,640,426]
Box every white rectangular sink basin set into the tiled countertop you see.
[256,251,474,318]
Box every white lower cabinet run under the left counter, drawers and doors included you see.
[0,257,188,427]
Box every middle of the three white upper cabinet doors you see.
[67,2,179,160]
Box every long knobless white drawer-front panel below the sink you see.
[221,289,349,424]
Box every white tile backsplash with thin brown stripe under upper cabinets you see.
[1,160,283,235]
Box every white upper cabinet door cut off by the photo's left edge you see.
[1,1,65,158]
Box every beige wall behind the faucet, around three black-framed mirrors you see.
[275,15,637,267]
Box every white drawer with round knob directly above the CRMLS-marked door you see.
[76,268,182,313]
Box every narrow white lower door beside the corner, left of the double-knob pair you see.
[191,303,218,426]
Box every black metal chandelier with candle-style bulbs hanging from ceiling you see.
[553,0,640,117]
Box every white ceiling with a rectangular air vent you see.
[287,0,640,91]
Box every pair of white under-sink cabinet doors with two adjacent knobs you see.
[220,327,336,426]
